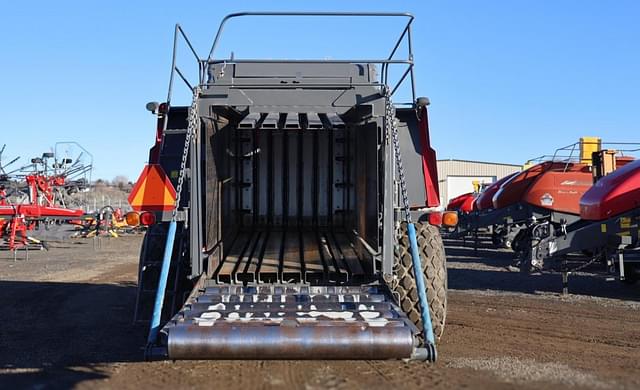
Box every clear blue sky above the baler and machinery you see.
[0,0,640,180]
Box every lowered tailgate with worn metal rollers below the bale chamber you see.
[162,285,415,359]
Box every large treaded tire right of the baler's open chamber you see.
[390,222,447,343]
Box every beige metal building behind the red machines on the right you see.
[438,159,522,206]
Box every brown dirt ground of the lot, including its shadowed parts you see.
[0,236,640,389]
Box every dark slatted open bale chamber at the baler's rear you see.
[205,113,381,285]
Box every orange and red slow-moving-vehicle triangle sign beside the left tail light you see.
[129,164,176,211]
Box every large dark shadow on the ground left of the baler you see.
[0,281,145,388]
